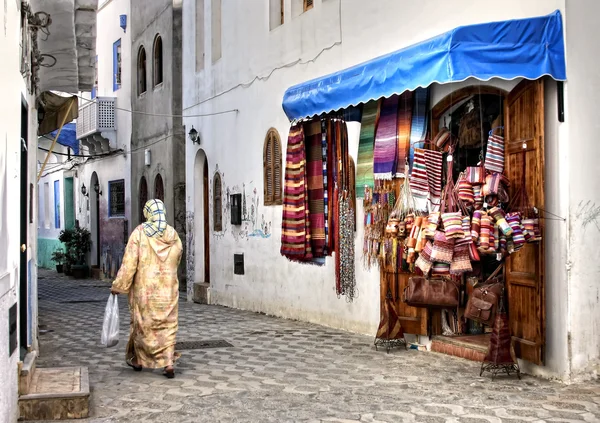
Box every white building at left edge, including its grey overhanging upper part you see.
[0,0,95,422]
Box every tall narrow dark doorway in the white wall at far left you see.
[19,98,31,360]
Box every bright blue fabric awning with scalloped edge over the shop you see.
[283,10,566,120]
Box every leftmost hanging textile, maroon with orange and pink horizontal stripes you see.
[280,125,313,261]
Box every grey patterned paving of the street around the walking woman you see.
[32,271,600,422]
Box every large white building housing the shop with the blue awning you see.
[183,0,600,380]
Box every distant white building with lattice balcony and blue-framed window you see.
[75,0,133,277]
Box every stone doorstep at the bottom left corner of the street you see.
[19,367,90,420]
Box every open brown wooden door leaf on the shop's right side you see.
[504,79,546,364]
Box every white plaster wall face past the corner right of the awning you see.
[561,0,600,379]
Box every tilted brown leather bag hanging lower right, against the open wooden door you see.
[465,264,504,326]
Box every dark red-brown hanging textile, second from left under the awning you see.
[304,120,325,257]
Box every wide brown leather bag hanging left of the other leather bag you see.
[404,276,459,308]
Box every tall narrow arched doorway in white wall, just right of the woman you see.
[194,150,210,283]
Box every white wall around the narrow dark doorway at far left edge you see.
[0,1,37,422]
